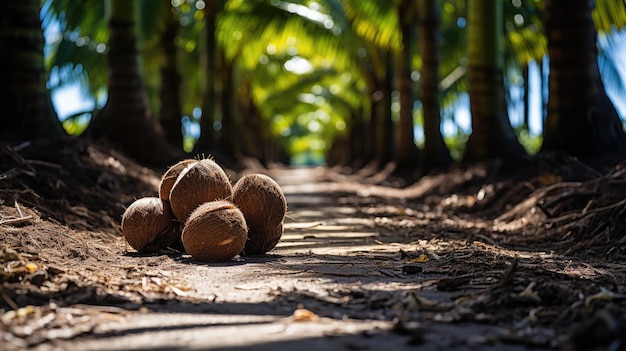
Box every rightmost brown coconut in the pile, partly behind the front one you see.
[233,174,287,255]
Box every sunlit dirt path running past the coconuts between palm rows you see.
[4,169,556,350]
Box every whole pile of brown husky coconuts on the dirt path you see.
[122,159,287,261]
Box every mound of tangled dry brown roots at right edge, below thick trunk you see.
[494,165,626,260]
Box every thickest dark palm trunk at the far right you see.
[542,0,626,160]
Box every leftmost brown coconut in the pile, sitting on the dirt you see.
[122,197,180,252]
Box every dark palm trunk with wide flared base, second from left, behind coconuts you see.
[87,0,178,164]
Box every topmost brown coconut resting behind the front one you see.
[170,159,233,223]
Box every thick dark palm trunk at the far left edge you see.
[0,0,65,139]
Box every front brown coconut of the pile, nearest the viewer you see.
[182,200,248,261]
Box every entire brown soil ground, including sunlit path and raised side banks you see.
[0,140,626,350]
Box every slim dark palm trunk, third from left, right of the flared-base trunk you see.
[159,1,183,150]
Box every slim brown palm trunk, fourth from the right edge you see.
[395,0,419,172]
